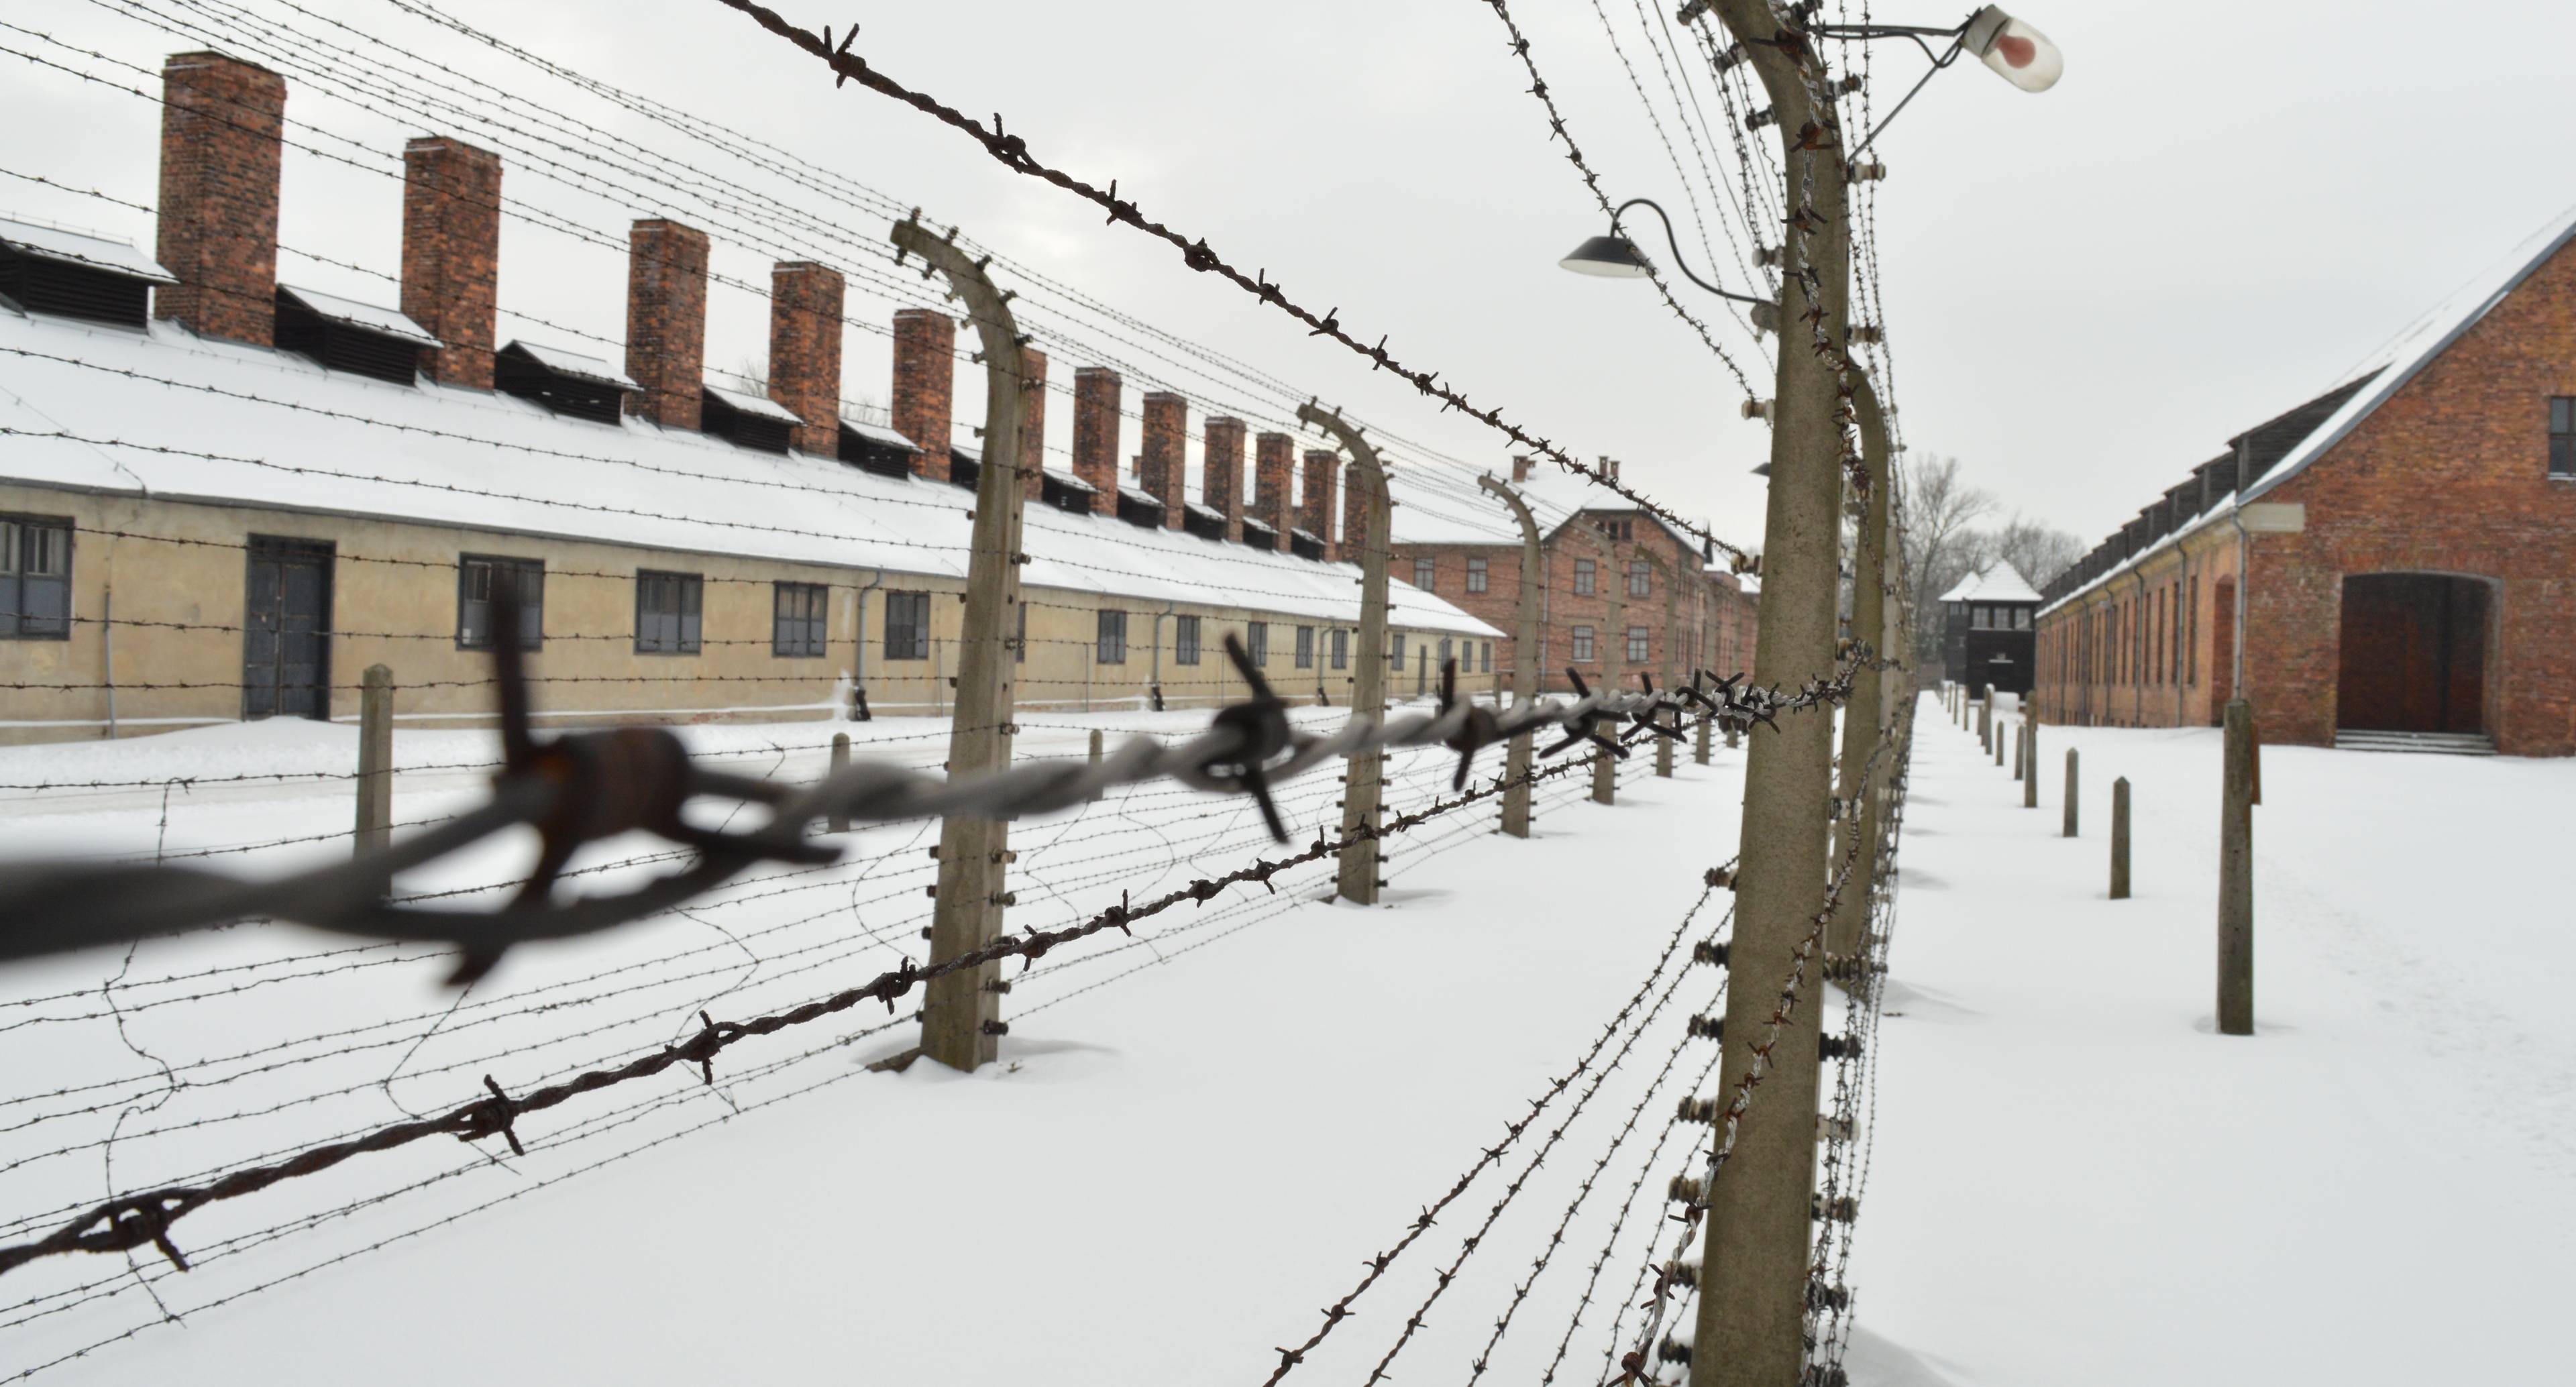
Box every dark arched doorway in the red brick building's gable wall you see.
[2334,574,2488,733]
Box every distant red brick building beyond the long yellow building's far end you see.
[1393,458,1754,692]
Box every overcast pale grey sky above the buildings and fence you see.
[0,0,2576,553]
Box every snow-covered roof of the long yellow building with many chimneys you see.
[0,314,1499,636]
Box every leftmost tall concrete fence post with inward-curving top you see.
[894,221,1038,1070]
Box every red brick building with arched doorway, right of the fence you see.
[2037,216,2576,757]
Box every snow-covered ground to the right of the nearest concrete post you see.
[1852,702,2576,1387]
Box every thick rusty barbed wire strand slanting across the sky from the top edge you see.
[695,0,1752,561]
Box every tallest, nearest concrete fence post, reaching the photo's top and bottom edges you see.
[1690,0,1860,1387]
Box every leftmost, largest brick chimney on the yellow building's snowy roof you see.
[152,54,286,347]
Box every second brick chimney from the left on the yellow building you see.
[402,136,500,391]
